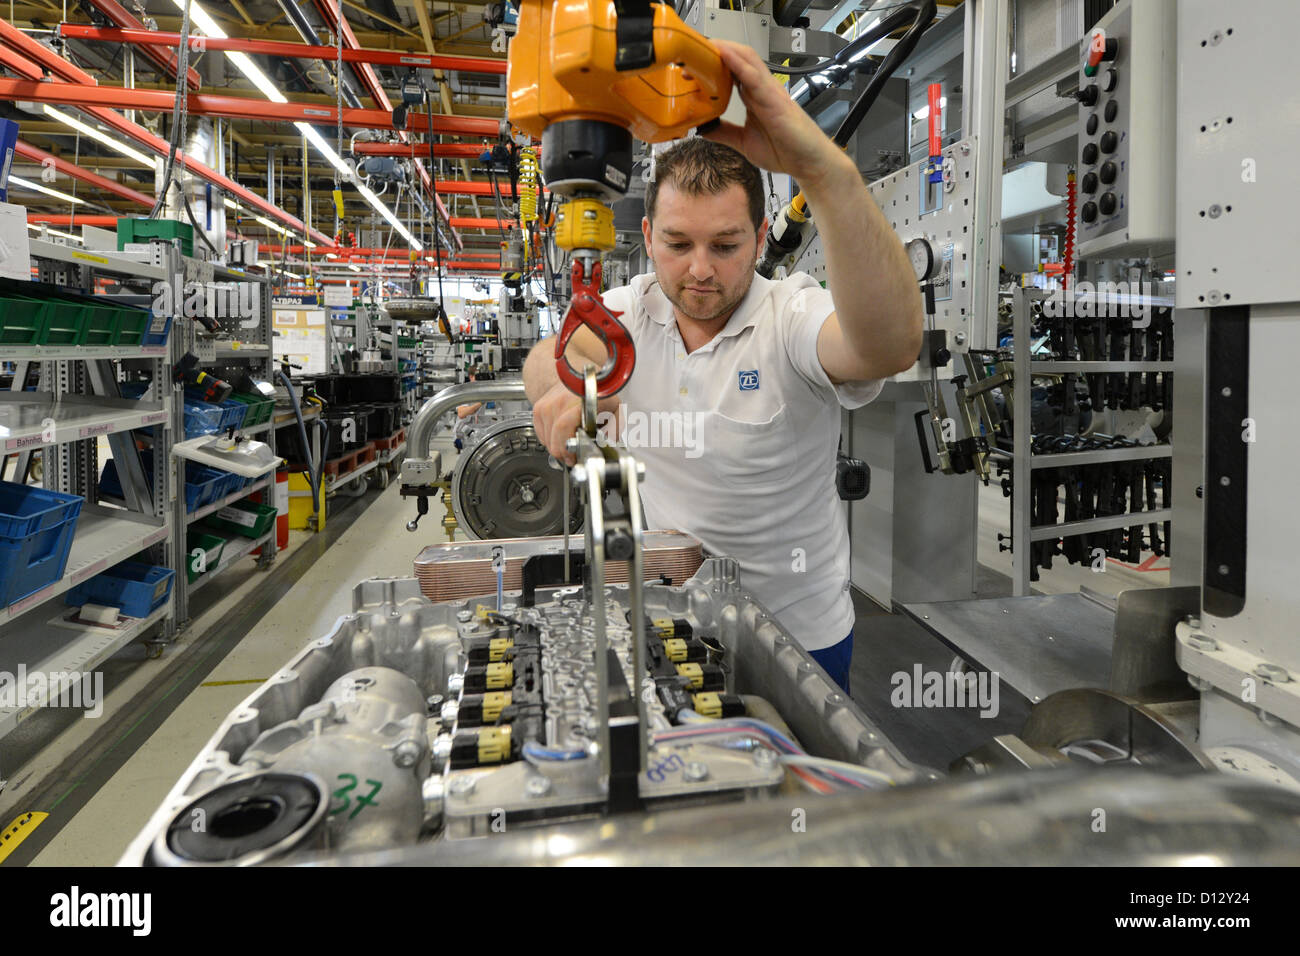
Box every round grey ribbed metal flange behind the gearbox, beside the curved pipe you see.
[451,416,582,538]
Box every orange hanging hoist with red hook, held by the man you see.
[507,0,732,398]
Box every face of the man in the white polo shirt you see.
[641,183,767,324]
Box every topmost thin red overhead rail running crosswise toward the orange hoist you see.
[59,25,506,75]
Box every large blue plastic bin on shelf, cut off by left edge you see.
[0,481,83,607]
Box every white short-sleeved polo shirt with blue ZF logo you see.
[603,273,884,650]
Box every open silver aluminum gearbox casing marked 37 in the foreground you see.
[121,558,939,865]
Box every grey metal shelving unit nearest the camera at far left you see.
[0,239,183,780]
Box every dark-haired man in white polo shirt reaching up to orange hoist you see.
[524,40,922,691]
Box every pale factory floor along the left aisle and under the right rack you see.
[12,449,1169,866]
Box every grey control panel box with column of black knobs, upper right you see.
[1076,0,1177,259]
